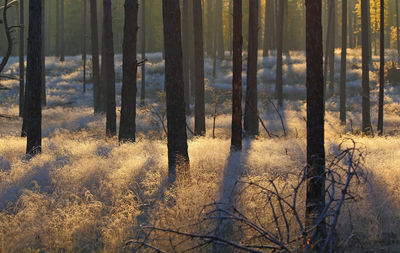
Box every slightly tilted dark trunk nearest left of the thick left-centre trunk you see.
[103,0,117,137]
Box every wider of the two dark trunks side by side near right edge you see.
[361,1,372,133]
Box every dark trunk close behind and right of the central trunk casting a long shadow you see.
[244,0,259,137]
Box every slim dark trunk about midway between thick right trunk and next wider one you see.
[340,0,347,125]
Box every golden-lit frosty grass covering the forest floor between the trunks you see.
[0,50,400,252]
